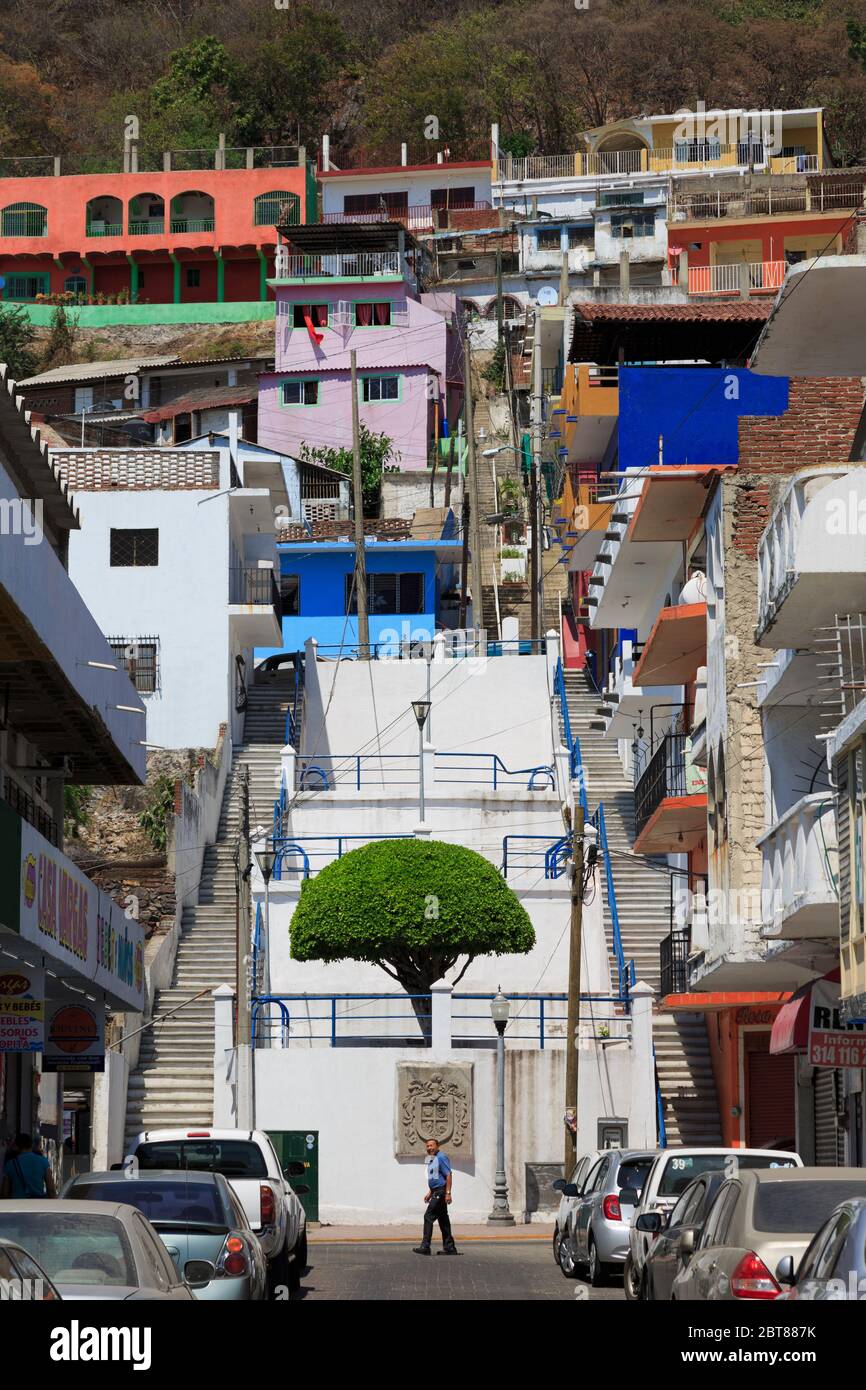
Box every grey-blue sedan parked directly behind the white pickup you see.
[61,1170,268,1302]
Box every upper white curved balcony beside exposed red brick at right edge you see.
[755,464,866,648]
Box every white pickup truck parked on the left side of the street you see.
[131,1129,307,1290]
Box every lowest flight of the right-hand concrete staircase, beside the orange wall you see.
[652,1013,721,1148]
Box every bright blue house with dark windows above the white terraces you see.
[264,512,461,659]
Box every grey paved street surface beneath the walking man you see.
[300,1238,623,1301]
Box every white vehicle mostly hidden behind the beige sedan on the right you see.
[623,1147,803,1300]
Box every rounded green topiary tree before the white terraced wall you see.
[289,840,535,1029]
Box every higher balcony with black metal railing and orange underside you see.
[634,734,706,855]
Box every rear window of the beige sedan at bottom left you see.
[0,1207,138,1287]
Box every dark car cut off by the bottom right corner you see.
[776,1197,866,1302]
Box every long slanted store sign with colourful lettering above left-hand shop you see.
[8,820,145,1011]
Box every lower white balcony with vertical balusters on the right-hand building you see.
[758,791,840,941]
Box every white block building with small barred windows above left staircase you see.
[53,448,289,748]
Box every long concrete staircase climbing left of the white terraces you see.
[126,673,286,1144]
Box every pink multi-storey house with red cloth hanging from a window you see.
[259,222,463,470]
